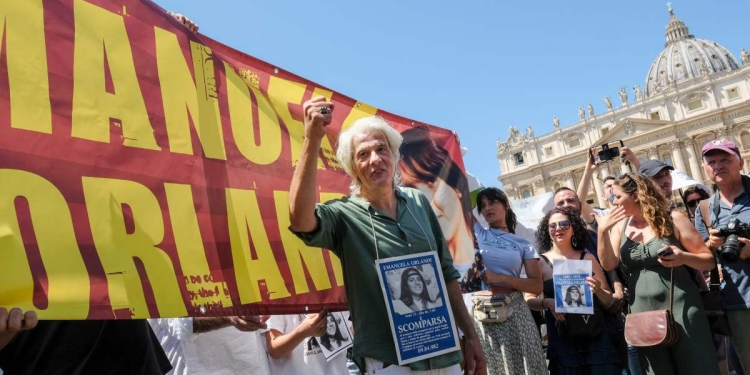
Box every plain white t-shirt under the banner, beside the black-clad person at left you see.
[149,318,271,375]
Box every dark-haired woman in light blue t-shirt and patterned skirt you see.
[472,187,546,375]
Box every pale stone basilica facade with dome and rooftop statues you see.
[497,8,750,207]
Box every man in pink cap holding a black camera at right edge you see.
[695,139,750,371]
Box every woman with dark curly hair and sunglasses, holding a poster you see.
[526,207,623,375]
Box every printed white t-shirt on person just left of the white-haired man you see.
[263,312,351,375]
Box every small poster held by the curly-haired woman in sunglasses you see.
[552,259,594,314]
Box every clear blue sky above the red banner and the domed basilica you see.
[156,0,750,186]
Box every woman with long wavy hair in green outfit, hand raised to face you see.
[598,174,719,375]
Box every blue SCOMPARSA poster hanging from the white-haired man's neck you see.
[375,252,460,365]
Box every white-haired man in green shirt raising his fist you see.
[289,97,486,375]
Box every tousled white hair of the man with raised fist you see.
[336,116,403,195]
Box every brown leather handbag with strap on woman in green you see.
[625,269,679,347]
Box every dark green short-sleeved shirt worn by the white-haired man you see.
[292,188,462,371]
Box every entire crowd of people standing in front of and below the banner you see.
[0,89,750,375]
